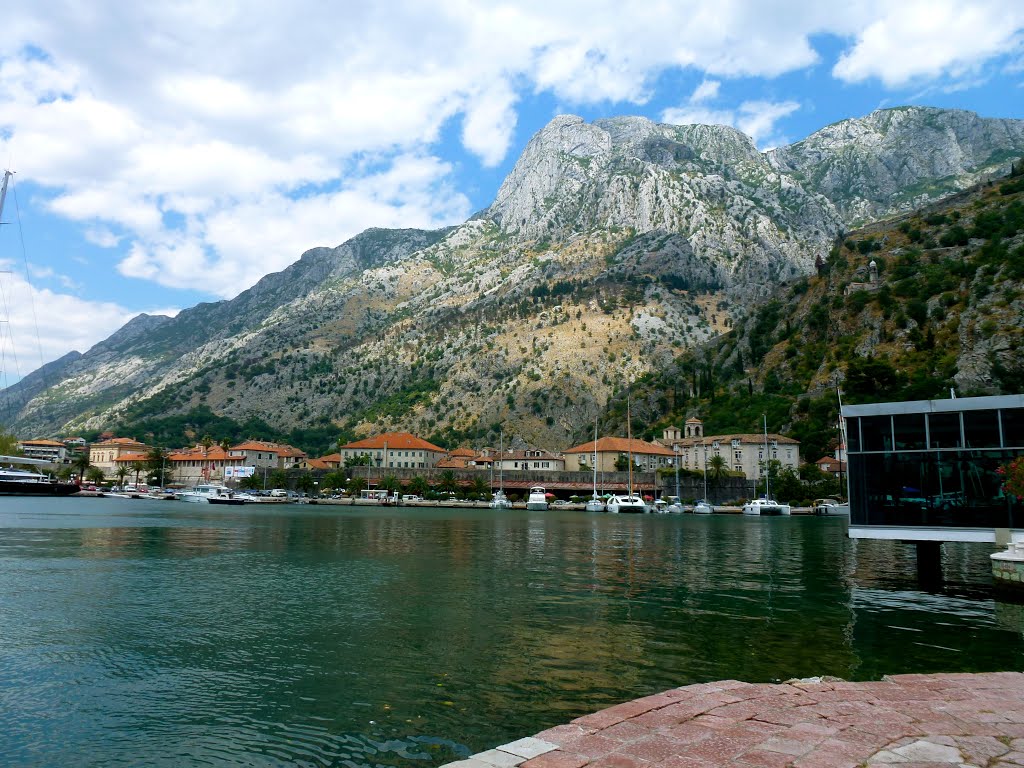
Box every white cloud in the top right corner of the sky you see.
[833,0,1024,87]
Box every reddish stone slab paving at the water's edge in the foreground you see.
[446,672,1024,768]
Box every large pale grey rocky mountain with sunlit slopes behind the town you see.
[0,108,1024,447]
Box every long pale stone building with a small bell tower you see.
[660,418,800,480]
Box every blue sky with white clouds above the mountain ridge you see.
[0,0,1024,387]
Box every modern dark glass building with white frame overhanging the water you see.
[843,394,1024,542]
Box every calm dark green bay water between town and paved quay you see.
[0,499,1024,767]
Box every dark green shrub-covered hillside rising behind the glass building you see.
[630,161,1024,461]
